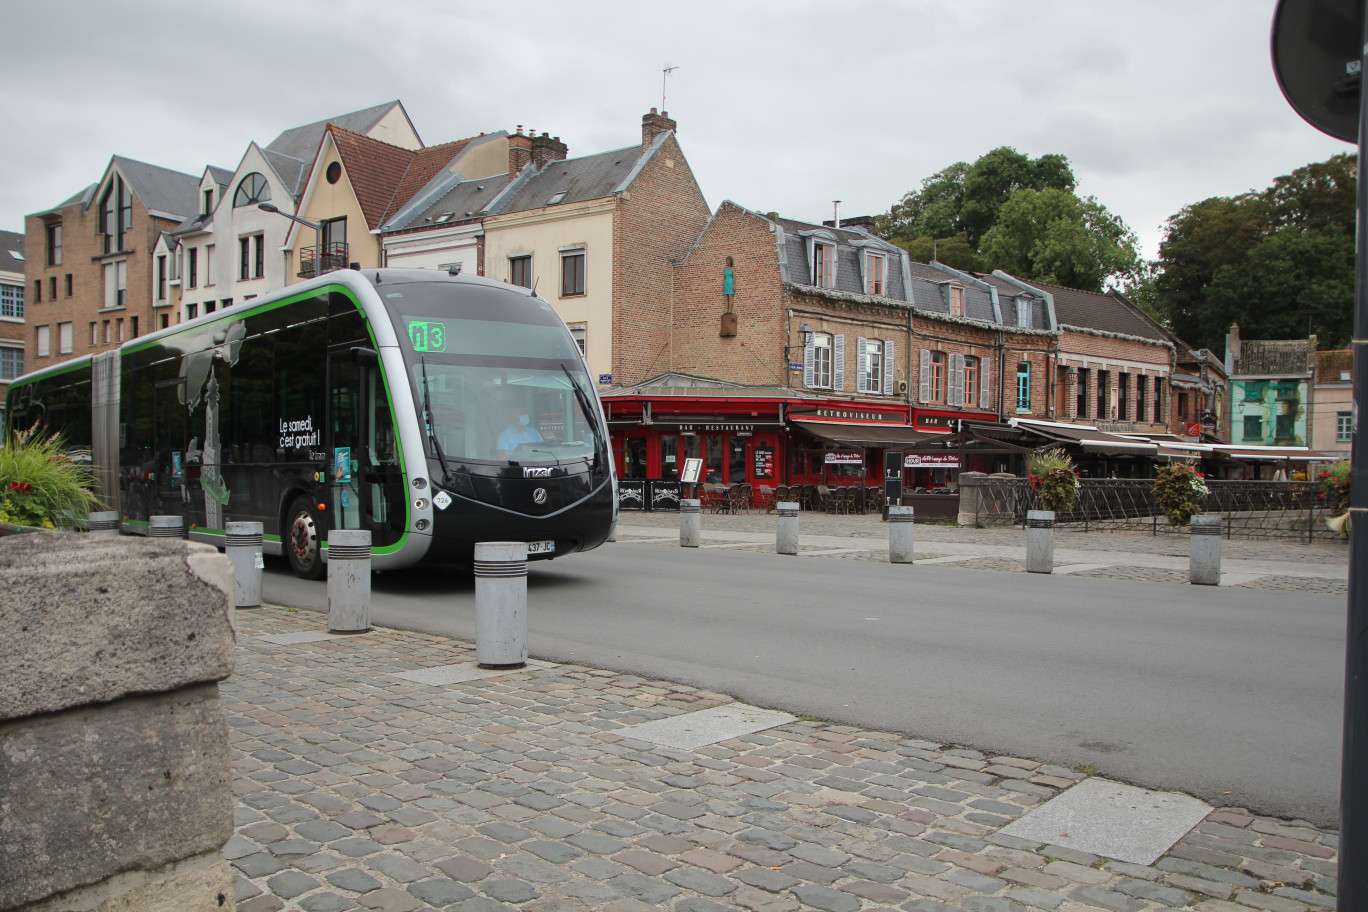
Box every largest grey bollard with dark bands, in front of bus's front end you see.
[475,541,527,669]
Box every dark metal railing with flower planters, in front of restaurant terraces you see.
[964,477,1339,541]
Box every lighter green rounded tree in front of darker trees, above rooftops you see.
[979,189,1140,291]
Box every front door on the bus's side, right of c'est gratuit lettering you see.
[327,347,406,546]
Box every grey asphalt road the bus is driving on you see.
[264,543,1345,826]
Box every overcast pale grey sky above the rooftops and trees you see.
[0,0,1353,257]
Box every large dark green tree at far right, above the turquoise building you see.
[1152,153,1357,351]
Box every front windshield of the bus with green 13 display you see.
[386,282,607,466]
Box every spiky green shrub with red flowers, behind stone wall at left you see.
[0,431,96,529]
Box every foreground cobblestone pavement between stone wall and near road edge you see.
[222,607,1338,912]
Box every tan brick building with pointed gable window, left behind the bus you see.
[25,156,200,371]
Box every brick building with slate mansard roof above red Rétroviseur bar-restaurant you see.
[605,201,1059,500]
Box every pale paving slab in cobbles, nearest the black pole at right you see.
[1001,777,1212,866]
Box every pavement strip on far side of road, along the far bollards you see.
[617,510,1349,595]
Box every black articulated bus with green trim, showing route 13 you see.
[7,269,617,578]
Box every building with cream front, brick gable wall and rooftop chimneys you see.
[483,108,709,387]
